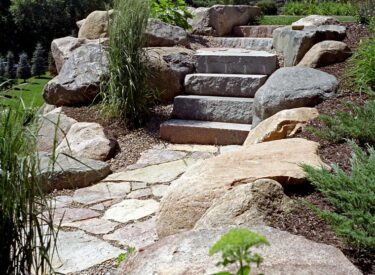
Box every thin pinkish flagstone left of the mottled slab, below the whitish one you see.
[64,218,118,235]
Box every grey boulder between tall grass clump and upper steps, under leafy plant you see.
[145,19,188,47]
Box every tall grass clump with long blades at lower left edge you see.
[0,104,56,274]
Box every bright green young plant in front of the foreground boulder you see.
[209,229,269,275]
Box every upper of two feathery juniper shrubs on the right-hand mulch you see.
[307,100,375,145]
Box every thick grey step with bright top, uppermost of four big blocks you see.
[195,48,277,75]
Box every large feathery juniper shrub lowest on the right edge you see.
[303,143,375,251]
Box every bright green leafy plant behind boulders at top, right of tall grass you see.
[151,0,193,29]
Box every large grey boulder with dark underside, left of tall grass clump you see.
[43,44,108,106]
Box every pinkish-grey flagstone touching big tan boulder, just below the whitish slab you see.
[103,218,158,249]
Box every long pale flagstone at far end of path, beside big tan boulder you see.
[104,159,197,184]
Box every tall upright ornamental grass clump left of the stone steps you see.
[101,0,156,126]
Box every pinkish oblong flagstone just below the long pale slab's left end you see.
[73,182,130,204]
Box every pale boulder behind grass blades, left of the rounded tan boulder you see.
[37,107,77,152]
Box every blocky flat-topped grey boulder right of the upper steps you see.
[273,25,346,67]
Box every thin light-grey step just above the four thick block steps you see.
[211,36,272,51]
